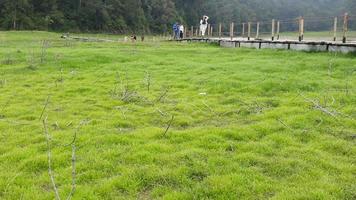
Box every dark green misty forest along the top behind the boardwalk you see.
[0,0,356,33]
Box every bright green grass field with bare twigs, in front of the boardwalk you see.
[0,32,356,200]
